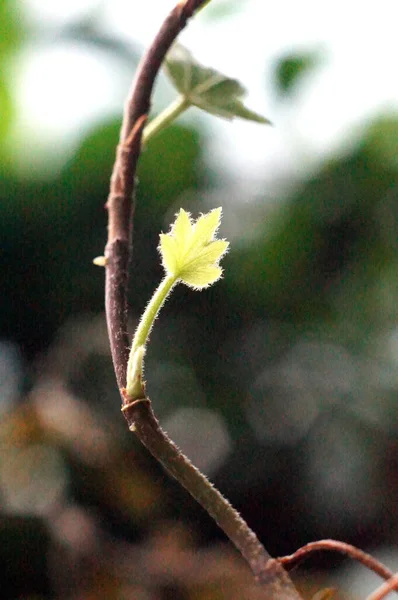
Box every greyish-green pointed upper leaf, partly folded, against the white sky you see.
[165,44,270,124]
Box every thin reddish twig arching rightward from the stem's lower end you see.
[278,540,393,580]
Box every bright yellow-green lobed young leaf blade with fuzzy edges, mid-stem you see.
[159,208,229,289]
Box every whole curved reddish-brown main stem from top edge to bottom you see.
[105,0,300,600]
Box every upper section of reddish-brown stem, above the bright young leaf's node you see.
[105,0,210,389]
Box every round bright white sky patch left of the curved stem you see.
[13,44,124,135]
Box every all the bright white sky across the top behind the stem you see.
[12,0,398,179]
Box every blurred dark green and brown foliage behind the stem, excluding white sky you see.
[0,0,398,600]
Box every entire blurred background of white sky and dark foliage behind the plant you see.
[0,0,398,600]
